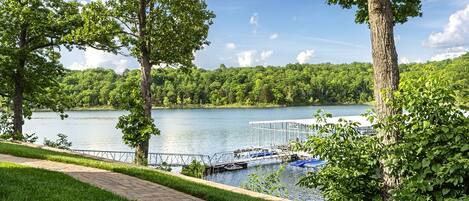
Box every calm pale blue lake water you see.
[24,105,370,200]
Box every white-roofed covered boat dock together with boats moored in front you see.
[247,116,374,168]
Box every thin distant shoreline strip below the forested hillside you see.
[33,102,372,112]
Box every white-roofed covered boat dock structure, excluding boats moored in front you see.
[249,116,373,147]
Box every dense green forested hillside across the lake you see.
[61,54,469,107]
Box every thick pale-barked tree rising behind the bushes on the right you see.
[327,0,422,200]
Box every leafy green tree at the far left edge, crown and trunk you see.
[0,0,82,140]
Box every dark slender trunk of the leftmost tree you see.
[13,27,27,140]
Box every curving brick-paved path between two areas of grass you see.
[0,154,201,201]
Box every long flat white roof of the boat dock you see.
[249,116,372,127]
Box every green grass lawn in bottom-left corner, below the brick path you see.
[0,162,127,201]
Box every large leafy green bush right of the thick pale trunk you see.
[382,77,469,200]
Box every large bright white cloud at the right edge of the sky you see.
[427,5,469,47]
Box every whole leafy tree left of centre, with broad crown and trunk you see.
[78,0,214,164]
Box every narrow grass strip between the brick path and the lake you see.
[0,142,262,201]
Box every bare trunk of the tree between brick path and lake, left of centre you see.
[135,0,151,165]
